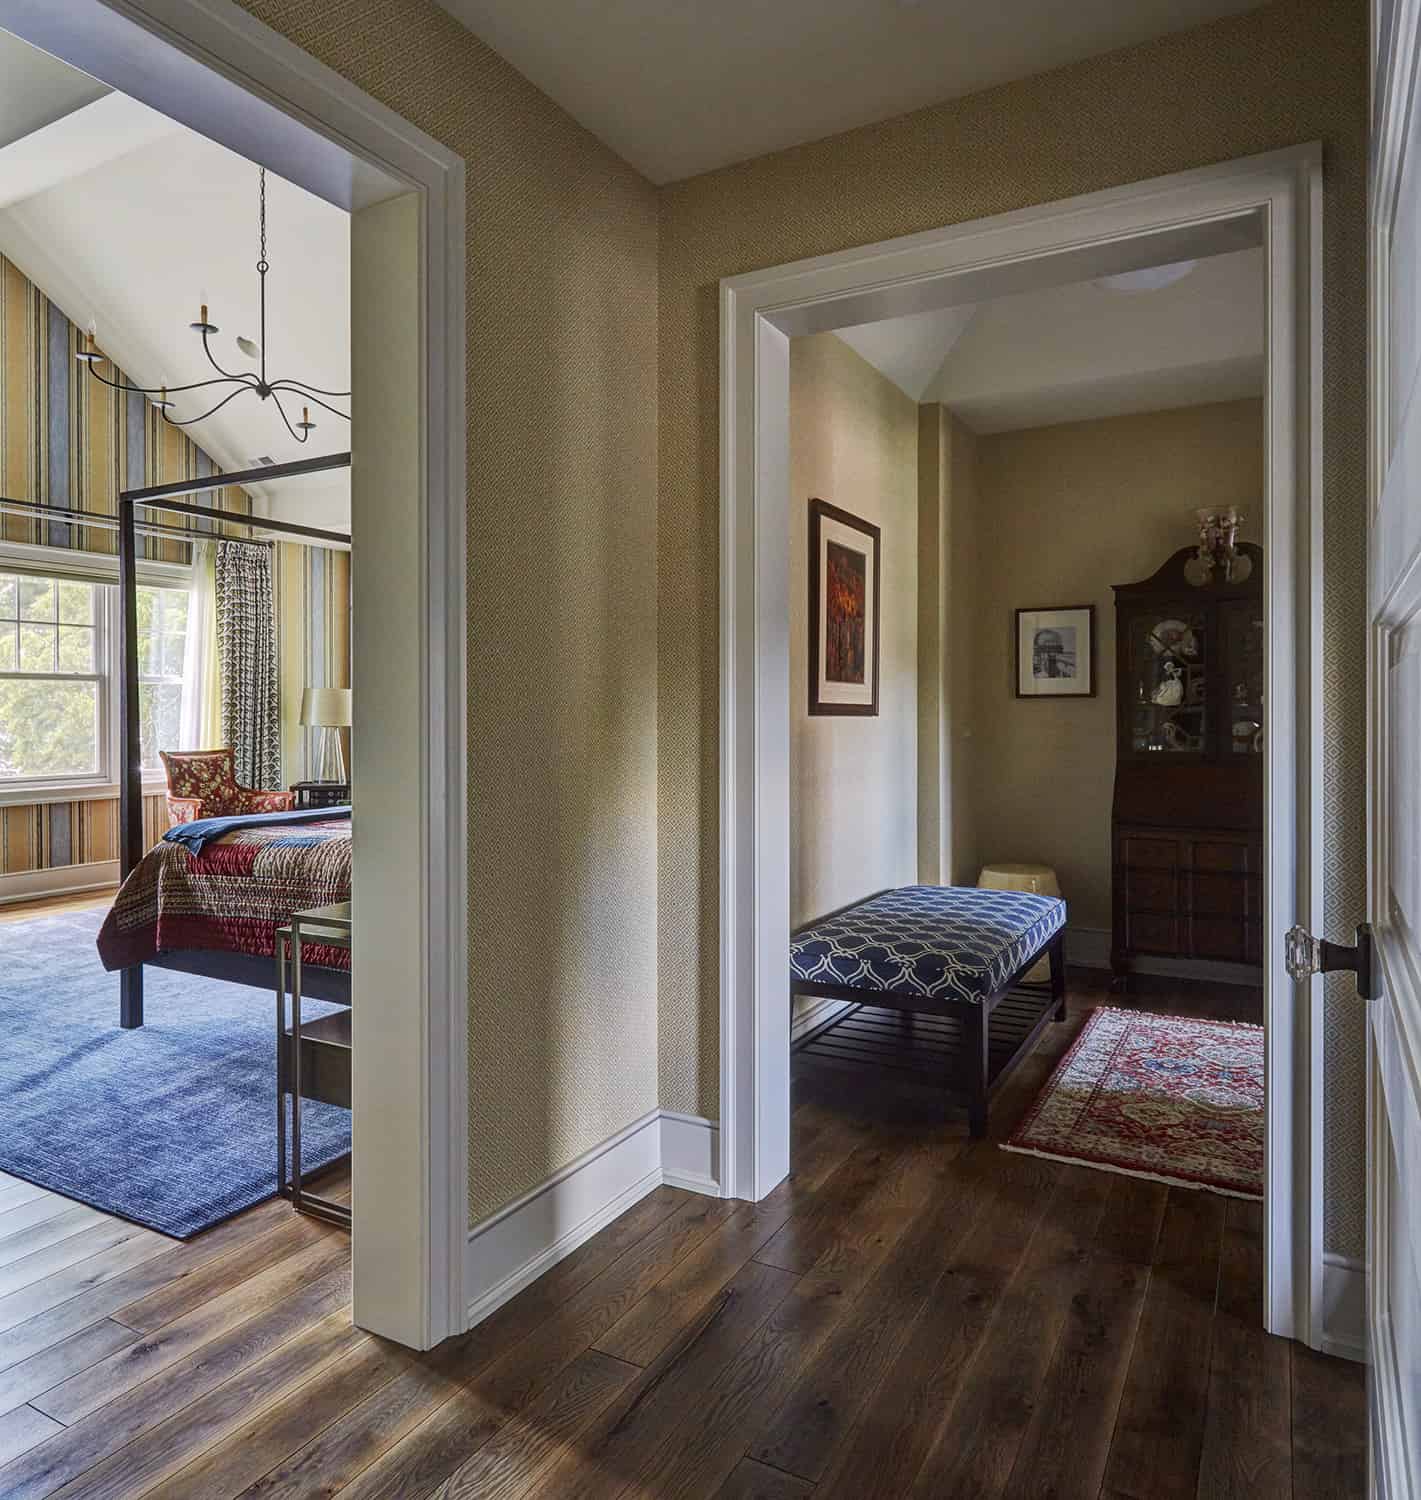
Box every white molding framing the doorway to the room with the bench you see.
[720,143,1323,1347]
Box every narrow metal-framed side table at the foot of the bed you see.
[276,902,353,1227]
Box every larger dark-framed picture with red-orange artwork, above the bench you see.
[809,498,882,717]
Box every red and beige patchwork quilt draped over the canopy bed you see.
[99,813,351,969]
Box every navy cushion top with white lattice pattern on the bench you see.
[789,885,1065,1004]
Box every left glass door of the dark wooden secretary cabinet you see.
[1124,606,1212,755]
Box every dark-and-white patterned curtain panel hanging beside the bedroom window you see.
[215,542,282,791]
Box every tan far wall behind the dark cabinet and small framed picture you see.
[972,401,1263,932]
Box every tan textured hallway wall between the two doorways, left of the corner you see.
[243,0,657,1221]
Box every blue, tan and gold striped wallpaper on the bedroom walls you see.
[0,255,350,876]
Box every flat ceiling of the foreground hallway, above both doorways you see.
[440,0,1257,183]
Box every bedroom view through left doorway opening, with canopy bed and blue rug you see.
[0,32,353,1248]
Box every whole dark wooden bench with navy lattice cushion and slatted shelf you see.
[789,885,1065,1136]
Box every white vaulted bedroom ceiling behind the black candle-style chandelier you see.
[0,71,350,525]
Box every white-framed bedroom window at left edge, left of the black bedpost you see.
[0,573,108,786]
